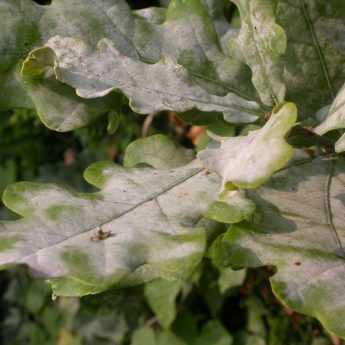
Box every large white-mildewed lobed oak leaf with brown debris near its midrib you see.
[0,138,219,296]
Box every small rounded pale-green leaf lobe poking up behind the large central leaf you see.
[124,134,194,169]
